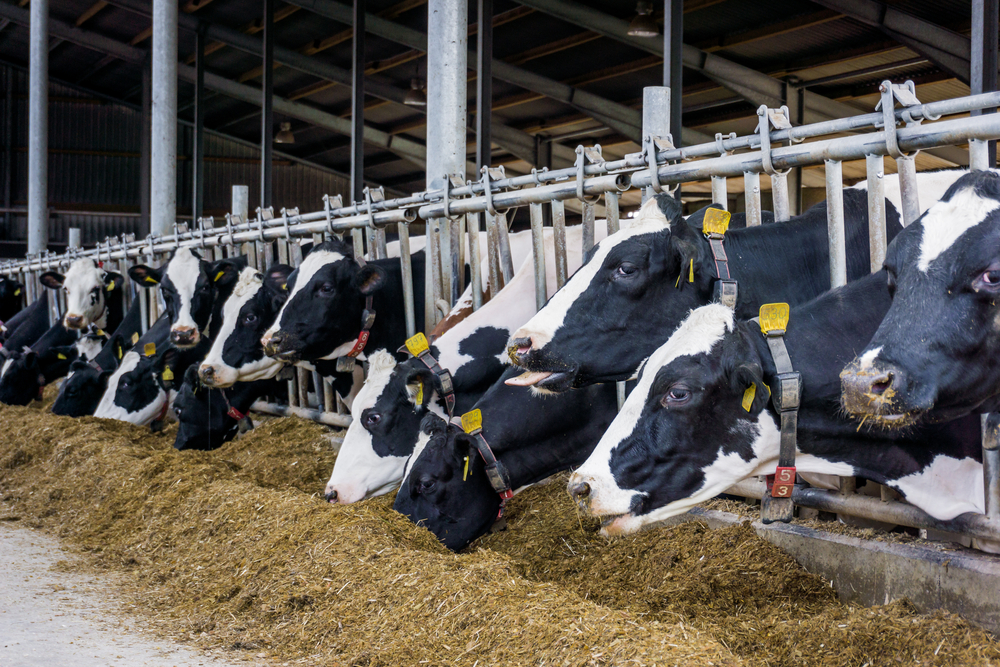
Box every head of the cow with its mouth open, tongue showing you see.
[508,196,696,391]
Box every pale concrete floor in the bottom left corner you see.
[0,523,263,667]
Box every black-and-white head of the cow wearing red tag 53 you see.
[568,304,780,535]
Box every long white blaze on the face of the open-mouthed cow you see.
[513,198,670,350]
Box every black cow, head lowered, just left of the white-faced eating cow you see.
[52,299,147,417]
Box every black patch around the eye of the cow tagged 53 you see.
[609,333,769,515]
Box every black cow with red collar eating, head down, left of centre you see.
[173,365,283,451]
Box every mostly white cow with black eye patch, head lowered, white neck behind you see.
[326,224,606,503]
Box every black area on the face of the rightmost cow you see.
[849,172,1000,425]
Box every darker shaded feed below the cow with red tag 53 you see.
[474,476,1000,667]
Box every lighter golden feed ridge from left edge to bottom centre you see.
[0,407,742,665]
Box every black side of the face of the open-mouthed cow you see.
[515,221,715,391]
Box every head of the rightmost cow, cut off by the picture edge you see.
[841,172,1000,428]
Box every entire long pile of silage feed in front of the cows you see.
[0,407,1000,667]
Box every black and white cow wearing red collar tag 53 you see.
[568,273,984,534]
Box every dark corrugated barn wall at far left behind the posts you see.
[0,68,348,257]
